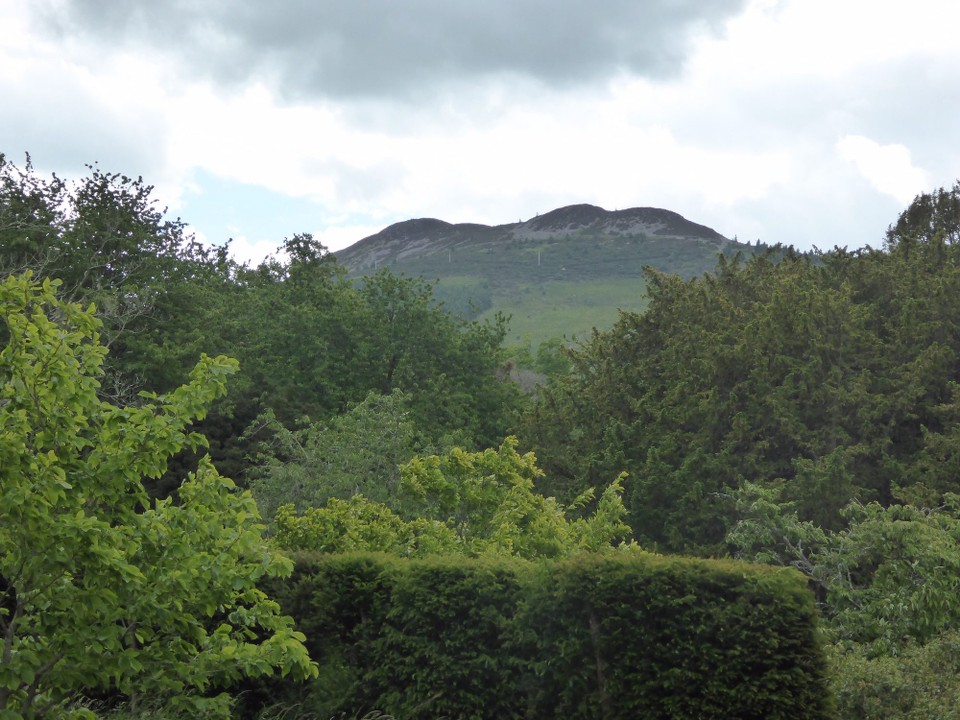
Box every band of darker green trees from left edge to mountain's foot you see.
[0,155,522,496]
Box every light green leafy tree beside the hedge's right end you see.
[727,483,960,656]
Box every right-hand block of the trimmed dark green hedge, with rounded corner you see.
[517,556,827,720]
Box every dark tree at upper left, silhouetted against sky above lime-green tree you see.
[0,154,227,403]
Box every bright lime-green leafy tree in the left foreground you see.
[0,273,314,720]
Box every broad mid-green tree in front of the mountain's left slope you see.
[210,250,522,480]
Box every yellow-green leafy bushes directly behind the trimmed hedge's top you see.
[276,437,630,558]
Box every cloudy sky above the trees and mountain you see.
[0,0,960,263]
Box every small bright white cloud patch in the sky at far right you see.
[837,135,930,205]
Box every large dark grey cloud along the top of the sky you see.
[41,0,745,97]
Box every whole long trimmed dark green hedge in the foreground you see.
[258,553,830,720]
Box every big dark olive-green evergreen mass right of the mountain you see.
[524,187,960,553]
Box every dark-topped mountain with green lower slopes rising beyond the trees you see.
[336,205,753,346]
